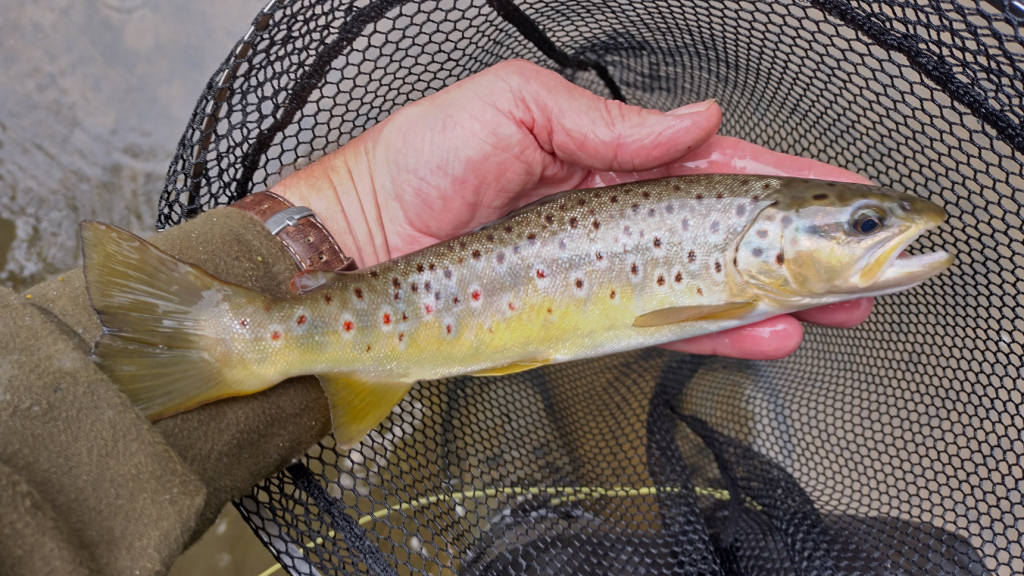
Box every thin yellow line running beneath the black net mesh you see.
[253,486,761,576]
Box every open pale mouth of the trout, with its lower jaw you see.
[858,222,954,294]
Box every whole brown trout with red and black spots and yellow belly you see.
[82,174,952,446]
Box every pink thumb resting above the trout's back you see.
[509,65,722,171]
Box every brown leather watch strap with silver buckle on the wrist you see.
[231,191,356,272]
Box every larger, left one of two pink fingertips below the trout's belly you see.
[663,316,804,360]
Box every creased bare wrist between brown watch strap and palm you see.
[271,141,390,268]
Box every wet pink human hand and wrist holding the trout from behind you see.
[273,60,871,359]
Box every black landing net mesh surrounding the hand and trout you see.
[158,0,1024,575]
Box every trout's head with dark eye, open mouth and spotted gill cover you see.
[733,179,953,302]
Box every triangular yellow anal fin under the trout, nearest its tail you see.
[316,374,413,449]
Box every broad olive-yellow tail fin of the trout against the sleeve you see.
[82,222,256,420]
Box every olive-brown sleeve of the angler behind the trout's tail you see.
[0,208,331,576]
